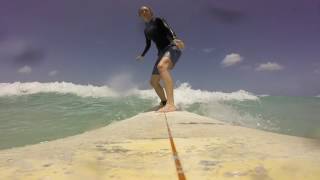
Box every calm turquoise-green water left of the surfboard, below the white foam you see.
[0,93,151,149]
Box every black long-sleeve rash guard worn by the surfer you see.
[141,17,177,56]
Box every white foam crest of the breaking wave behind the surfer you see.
[0,82,258,102]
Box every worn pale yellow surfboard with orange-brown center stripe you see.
[0,111,320,180]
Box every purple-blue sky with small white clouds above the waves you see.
[0,0,320,96]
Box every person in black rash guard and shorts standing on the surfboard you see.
[137,6,184,112]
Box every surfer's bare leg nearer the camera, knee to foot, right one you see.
[157,56,176,112]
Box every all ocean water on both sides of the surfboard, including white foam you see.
[0,82,320,149]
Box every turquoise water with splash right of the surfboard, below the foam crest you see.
[187,96,320,139]
